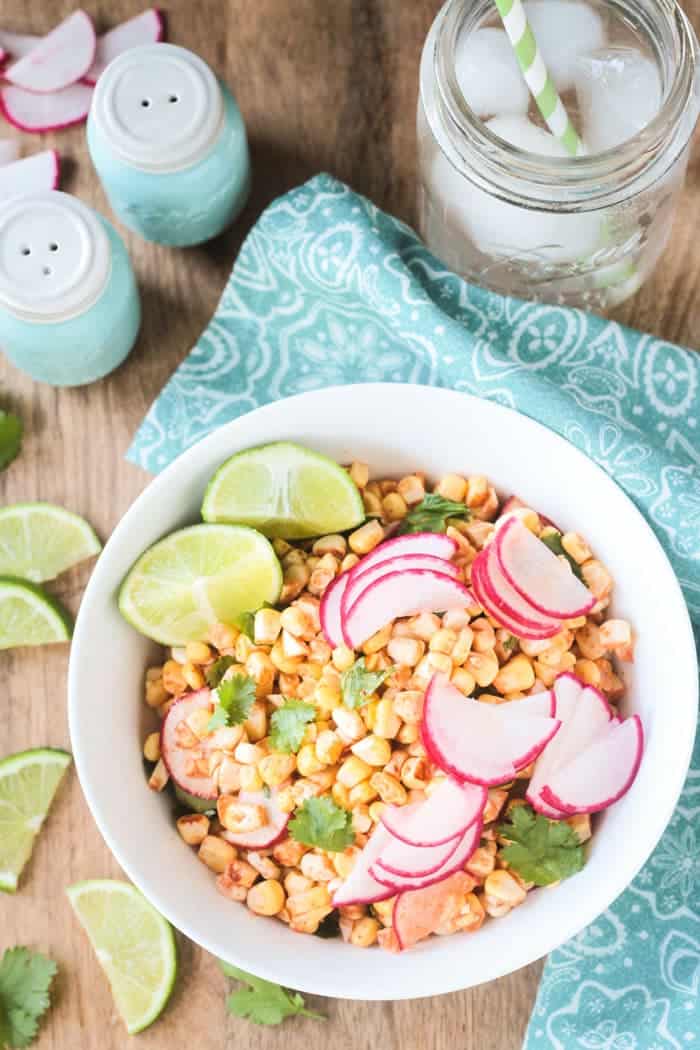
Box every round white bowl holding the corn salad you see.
[69,384,698,1000]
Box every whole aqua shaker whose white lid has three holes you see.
[0,190,141,386]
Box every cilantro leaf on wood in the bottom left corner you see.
[0,948,57,1048]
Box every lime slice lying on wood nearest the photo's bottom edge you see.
[66,879,177,1035]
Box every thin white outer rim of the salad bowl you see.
[68,383,698,1001]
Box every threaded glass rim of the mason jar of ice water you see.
[428,0,698,211]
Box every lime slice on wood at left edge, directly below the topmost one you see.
[0,576,71,649]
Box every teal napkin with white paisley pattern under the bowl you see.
[128,175,700,1050]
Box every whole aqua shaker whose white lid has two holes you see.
[87,44,250,247]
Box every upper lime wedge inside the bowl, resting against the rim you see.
[201,441,364,540]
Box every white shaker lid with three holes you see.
[0,190,111,323]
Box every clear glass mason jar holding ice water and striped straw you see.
[418,0,698,309]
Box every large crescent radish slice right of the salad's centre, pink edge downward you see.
[422,675,560,788]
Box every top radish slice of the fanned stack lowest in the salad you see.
[380,777,488,860]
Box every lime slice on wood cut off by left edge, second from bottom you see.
[0,748,70,894]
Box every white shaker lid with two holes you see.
[90,44,224,173]
